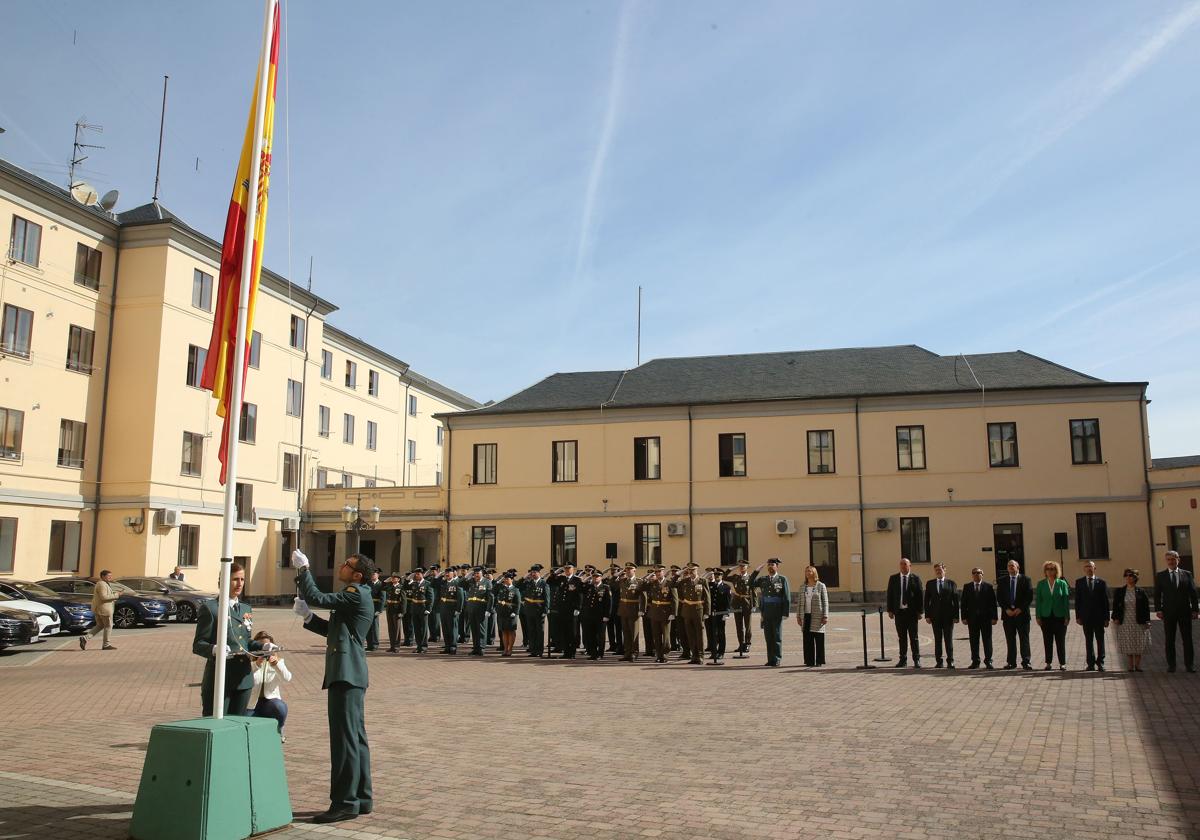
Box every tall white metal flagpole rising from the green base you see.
[212,0,278,719]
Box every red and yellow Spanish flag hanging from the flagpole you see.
[200,2,280,484]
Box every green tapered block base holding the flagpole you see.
[130,716,292,840]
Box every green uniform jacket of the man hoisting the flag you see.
[296,569,374,689]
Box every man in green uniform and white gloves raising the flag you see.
[292,551,376,822]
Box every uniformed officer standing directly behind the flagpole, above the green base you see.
[192,563,268,718]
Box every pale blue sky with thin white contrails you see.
[0,0,1200,457]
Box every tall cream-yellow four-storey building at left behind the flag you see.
[0,161,478,595]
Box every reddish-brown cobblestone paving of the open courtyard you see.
[0,608,1200,840]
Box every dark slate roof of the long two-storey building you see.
[456,344,1132,415]
